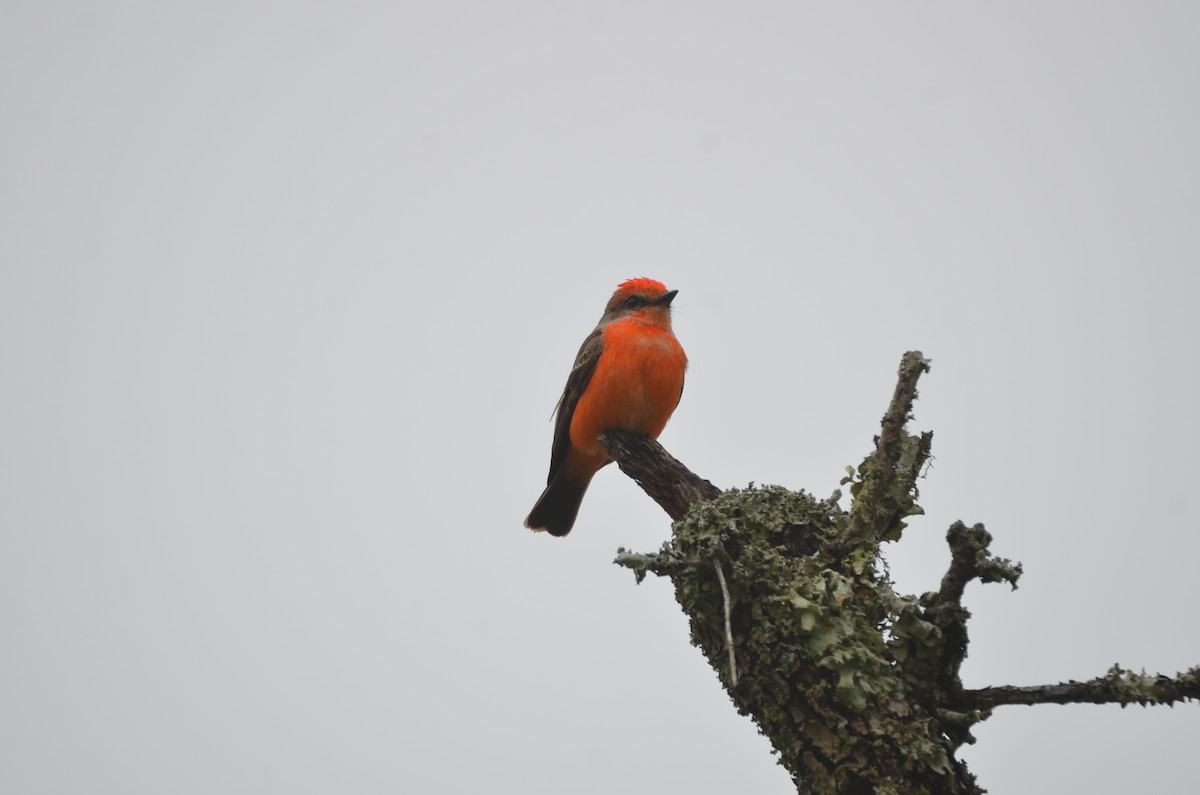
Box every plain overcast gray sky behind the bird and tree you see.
[0,0,1200,795]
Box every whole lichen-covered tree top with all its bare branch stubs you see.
[601,352,1200,795]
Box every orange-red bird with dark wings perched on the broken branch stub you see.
[526,279,688,536]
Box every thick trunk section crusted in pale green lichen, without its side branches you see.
[618,486,977,793]
